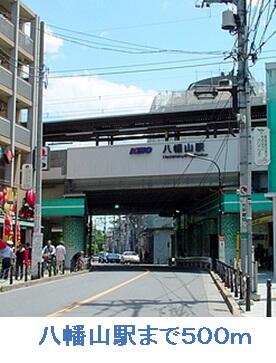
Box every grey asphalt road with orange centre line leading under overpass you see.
[0,271,231,317]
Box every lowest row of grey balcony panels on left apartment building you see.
[0,117,31,151]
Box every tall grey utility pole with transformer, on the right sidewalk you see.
[201,0,253,296]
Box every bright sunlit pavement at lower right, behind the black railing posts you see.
[241,272,276,318]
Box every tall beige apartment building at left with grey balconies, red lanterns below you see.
[0,0,39,242]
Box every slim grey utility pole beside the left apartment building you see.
[32,21,45,279]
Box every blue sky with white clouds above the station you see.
[24,0,276,121]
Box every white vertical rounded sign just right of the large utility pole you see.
[252,127,270,166]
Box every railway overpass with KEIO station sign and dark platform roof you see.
[43,82,271,268]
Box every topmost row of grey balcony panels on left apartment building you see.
[0,15,34,61]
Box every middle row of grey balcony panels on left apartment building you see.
[0,66,32,108]
